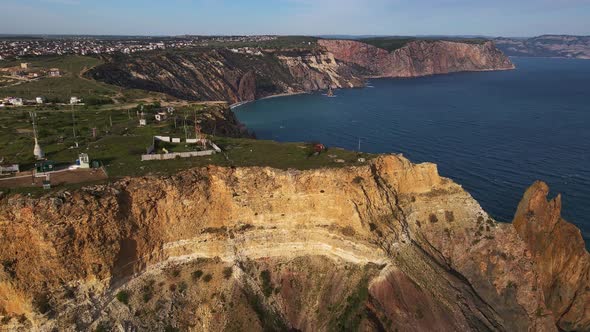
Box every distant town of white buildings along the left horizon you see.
[0,36,276,60]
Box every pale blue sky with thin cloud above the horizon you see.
[0,0,590,36]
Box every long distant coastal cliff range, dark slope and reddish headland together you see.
[88,39,514,103]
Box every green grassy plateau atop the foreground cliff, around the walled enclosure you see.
[0,104,371,192]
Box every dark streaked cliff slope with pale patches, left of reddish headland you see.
[88,50,363,103]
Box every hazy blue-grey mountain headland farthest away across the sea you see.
[494,35,590,59]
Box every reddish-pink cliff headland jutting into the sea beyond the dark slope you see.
[318,40,514,77]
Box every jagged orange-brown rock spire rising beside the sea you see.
[514,182,590,331]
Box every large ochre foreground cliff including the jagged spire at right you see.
[0,156,590,331]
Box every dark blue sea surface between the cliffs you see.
[235,58,590,244]
